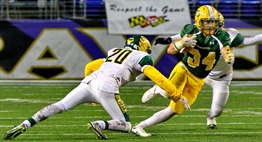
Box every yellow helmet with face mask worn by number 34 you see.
[195,5,219,36]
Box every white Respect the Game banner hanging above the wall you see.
[105,0,191,35]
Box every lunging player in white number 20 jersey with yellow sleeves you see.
[4,36,188,140]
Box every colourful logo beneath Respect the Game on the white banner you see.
[128,15,169,28]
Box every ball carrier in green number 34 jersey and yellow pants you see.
[132,5,233,137]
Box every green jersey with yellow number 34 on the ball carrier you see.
[180,24,230,78]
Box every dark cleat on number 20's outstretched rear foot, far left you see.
[4,124,26,140]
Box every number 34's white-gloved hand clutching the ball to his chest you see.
[174,34,197,50]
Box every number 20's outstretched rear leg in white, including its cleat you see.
[4,83,91,140]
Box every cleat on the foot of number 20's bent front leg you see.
[87,122,107,140]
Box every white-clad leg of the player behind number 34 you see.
[205,78,230,129]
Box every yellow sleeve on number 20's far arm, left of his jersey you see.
[84,59,104,76]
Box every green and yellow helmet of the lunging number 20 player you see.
[125,35,152,54]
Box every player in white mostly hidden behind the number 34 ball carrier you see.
[142,13,262,129]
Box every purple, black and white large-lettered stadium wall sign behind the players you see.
[0,20,262,80]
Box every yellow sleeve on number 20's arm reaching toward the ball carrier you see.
[143,66,182,102]
